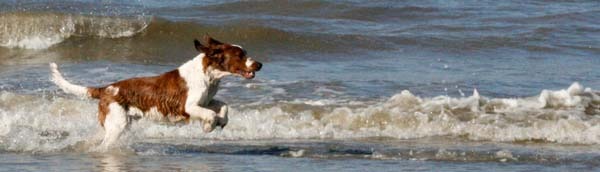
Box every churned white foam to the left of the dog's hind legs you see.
[0,92,98,152]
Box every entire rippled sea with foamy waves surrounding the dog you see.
[0,0,600,171]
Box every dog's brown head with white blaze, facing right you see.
[194,35,262,79]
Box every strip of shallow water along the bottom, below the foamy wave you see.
[0,139,598,171]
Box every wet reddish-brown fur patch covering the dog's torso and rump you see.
[94,70,189,126]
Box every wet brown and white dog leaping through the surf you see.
[50,36,262,147]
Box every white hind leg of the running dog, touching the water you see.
[100,102,127,149]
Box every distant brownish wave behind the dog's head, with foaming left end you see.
[0,12,366,63]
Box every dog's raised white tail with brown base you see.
[50,63,105,99]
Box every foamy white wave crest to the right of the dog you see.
[191,83,600,144]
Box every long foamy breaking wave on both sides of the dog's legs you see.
[0,83,600,152]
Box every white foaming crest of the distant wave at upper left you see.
[0,12,150,49]
